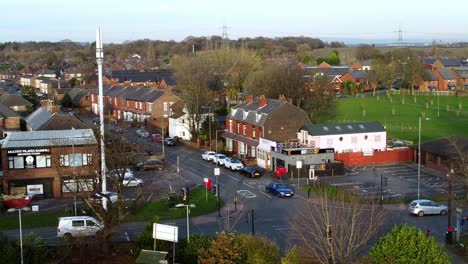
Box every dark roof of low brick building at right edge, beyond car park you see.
[414,136,468,159]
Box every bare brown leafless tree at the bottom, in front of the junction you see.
[291,187,383,263]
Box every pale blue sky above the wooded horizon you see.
[0,0,468,43]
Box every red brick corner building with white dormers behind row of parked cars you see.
[222,96,310,157]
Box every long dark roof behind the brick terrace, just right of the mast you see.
[111,69,176,85]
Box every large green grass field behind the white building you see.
[324,94,468,142]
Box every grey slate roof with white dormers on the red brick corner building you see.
[227,98,287,126]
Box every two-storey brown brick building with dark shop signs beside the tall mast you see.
[0,129,99,198]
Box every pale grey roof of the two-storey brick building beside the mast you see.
[2,129,97,149]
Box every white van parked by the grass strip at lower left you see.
[57,216,104,239]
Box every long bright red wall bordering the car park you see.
[335,148,413,166]
